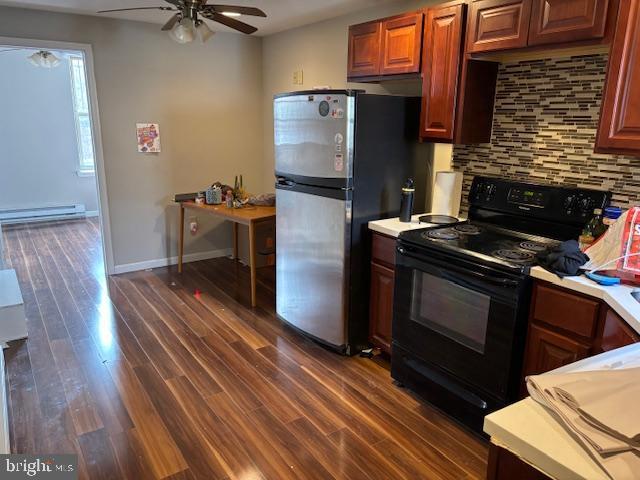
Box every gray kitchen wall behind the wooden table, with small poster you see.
[0,7,263,267]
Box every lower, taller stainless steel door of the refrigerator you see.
[276,189,351,347]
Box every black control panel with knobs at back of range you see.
[469,177,611,224]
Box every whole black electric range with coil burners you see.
[391,177,611,432]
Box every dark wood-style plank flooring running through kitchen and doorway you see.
[4,221,487,480]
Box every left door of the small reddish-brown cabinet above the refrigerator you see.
[347,22,381,77]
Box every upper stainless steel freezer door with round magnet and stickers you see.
[274,93,355,179]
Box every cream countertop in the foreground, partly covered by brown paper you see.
[484,343,640,480]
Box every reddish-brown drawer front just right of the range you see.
[533,285,599,339]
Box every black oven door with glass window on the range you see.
[393,243,528,399]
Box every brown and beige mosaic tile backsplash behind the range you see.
[453,54,640,210]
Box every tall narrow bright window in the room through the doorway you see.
[69,55,95,176]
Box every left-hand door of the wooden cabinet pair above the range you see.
[467,0,531,53]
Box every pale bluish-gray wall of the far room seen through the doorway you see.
[0,51,98,211]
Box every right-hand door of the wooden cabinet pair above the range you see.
[529,0,609,45]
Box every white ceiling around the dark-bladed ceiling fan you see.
[0,0,393,35]
